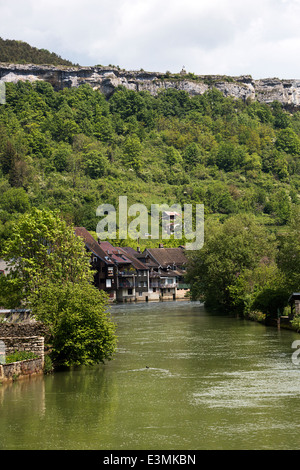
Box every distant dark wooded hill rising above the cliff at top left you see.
[0,38,72,65]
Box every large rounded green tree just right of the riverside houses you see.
[188,216,275,311]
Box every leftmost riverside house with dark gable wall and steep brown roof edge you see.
[75,227,118,301]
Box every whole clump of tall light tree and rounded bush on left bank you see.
[0,209,116,366]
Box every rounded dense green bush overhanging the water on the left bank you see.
[30,281,116,366]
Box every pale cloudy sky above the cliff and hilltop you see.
[0,0,300,79]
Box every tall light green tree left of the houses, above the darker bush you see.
[1,209,92,304]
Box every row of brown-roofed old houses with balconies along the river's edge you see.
[75,227,189,302]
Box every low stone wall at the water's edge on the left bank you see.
[0,358,44,383]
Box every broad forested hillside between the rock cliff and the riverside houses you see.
[0,82,300,258]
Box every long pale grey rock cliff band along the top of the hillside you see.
[0,63,300,108]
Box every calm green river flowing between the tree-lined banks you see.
[0,301,300,450]
